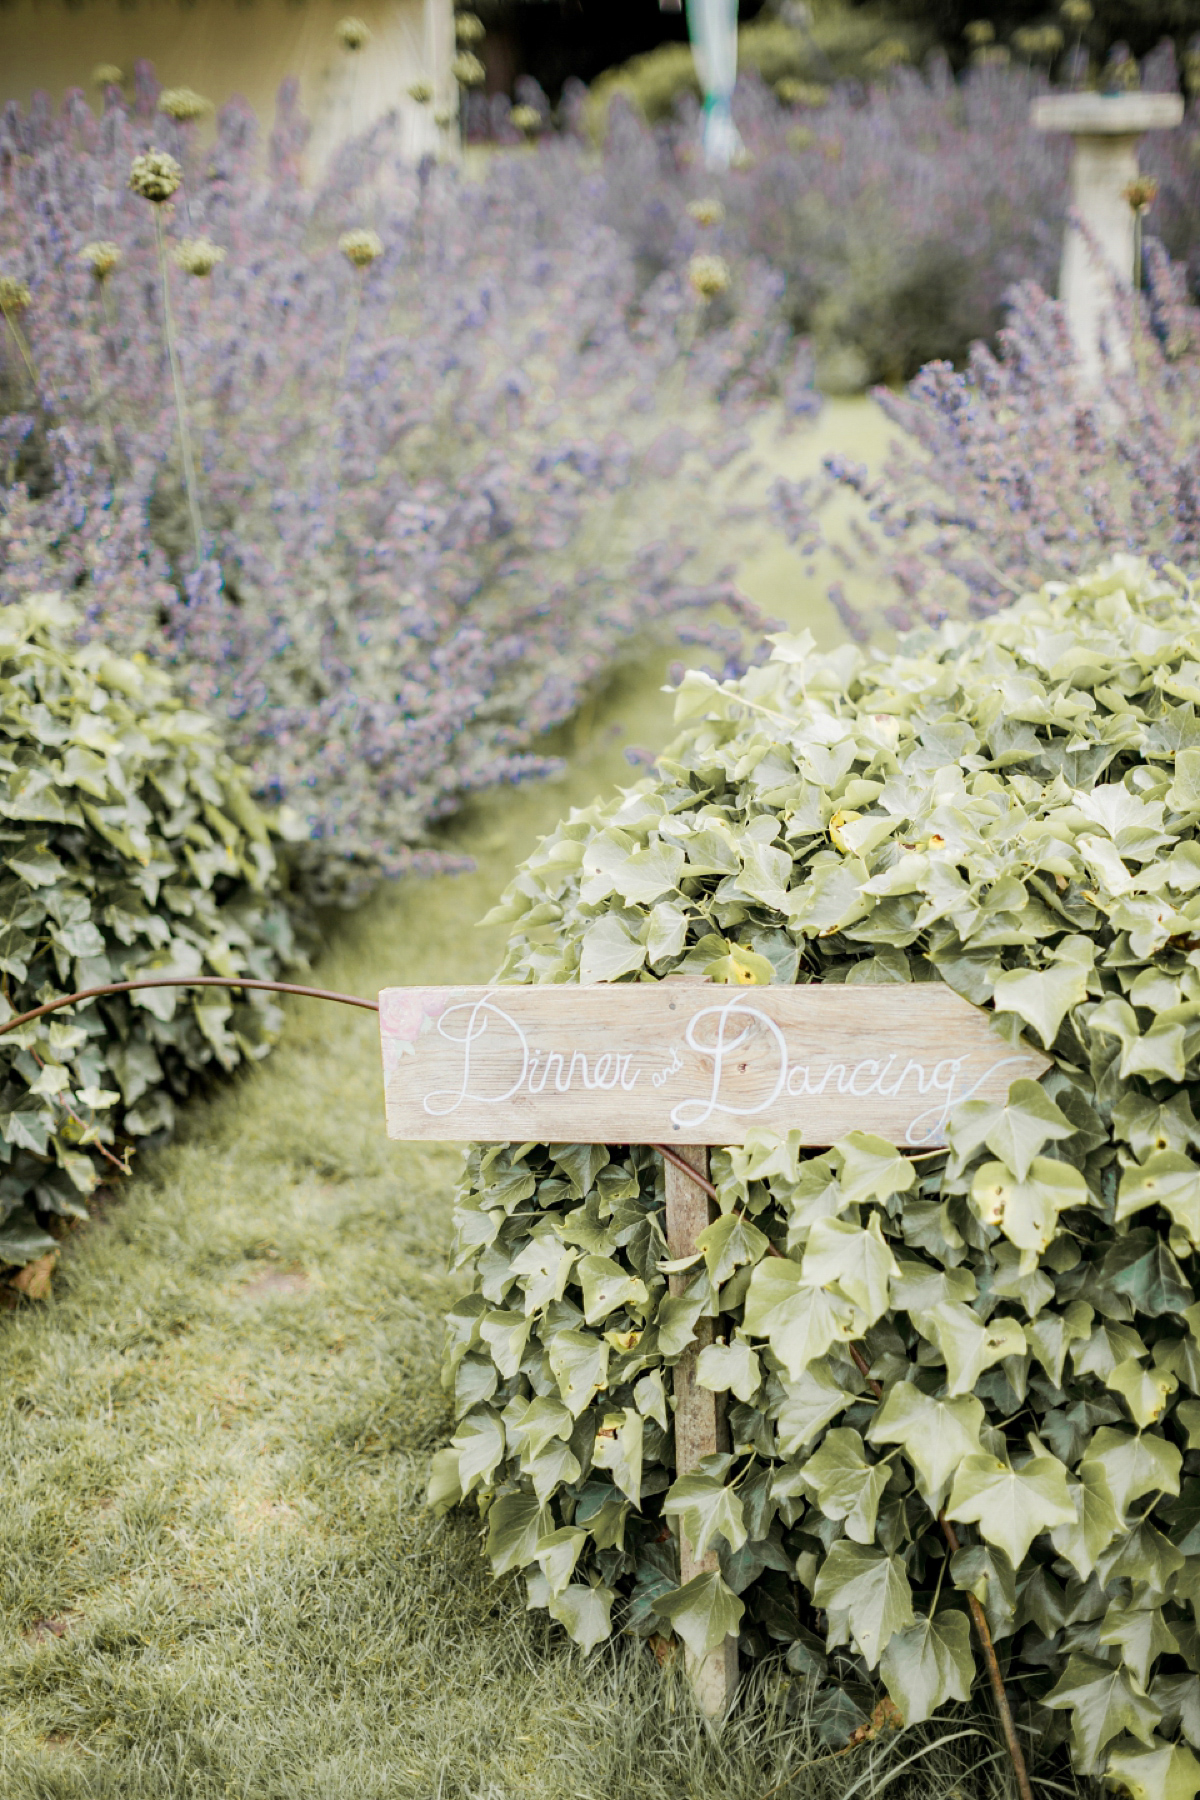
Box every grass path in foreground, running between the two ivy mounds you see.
[0,677,1004,1800]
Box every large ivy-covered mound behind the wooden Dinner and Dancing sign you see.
[430,558,1200,1796]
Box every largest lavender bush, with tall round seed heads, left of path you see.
[0,67,806,898]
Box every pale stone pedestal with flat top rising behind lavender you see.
[1033,94,1184,376]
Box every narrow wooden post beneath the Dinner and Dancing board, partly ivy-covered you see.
[664,1145,738,1719]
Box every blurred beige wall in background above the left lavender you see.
[0,0,453,166]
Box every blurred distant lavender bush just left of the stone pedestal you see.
[590,58,1069,387]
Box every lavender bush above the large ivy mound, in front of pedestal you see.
[798,239,1200,637]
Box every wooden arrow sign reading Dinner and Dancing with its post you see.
[380,981,1051,1717]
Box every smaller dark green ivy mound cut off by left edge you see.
[0,596,293,1264]
